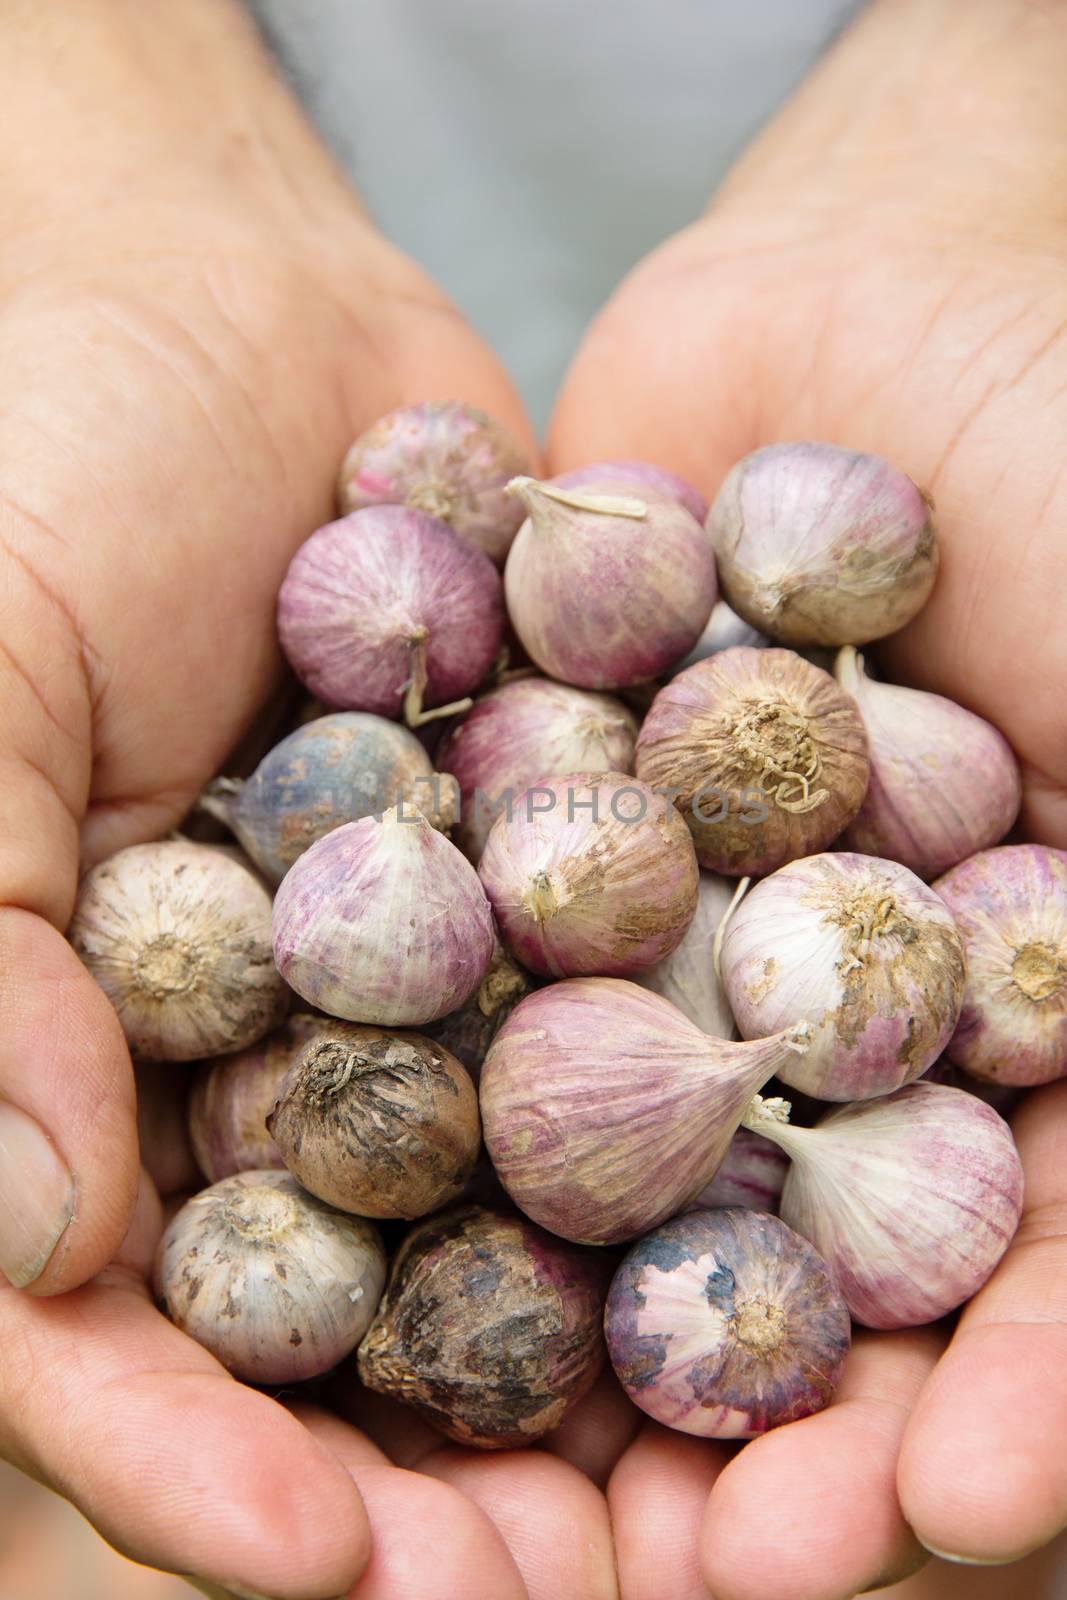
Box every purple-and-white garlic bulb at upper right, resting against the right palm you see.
[707,443,937,645]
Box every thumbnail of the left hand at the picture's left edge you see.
[0,1101,74,1290]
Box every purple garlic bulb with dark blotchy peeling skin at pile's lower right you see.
[605,1208,851,1438]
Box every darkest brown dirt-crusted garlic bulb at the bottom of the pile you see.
[358,1206,609,1450]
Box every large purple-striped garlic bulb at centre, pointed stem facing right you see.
[482,978,808,1245]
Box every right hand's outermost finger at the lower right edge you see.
[897,1083,1067,1562]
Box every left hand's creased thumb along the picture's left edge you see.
[0,544,138,1293]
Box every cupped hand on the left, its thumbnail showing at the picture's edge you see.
[0,0,614,1600]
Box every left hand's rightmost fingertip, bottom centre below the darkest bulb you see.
[419,1446,619,1600]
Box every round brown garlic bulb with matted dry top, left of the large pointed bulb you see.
[267,1022,482,1218]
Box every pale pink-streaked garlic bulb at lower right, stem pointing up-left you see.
[745,1083,1022,1328]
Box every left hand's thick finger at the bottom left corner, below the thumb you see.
[0,1285,370,1600]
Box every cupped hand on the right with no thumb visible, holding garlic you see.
[550,0,1067,1600]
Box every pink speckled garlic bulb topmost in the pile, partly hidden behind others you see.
[338,400,530,566]
